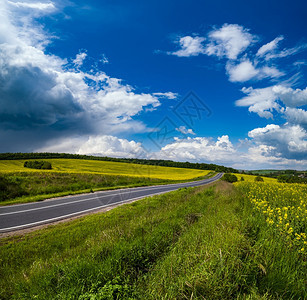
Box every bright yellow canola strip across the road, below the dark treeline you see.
[0,159,210,180]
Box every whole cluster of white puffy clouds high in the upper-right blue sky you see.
[164,24,294,82]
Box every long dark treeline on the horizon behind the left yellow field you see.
[0,152,239,173]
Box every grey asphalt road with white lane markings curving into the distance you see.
[0,173,223,233]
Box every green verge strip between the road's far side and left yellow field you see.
[0,172,173,205]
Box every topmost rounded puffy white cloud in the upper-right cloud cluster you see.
[206,24,256,59]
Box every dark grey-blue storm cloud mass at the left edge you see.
[0,66,82,130]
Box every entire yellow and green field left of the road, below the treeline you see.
[0,159,213,205]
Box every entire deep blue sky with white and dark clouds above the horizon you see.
[0,0,307,169]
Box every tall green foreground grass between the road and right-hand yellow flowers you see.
[0,182,306,300]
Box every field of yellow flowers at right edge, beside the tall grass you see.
[235,181,307,255]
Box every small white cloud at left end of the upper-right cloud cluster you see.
[167,36,205,57]
